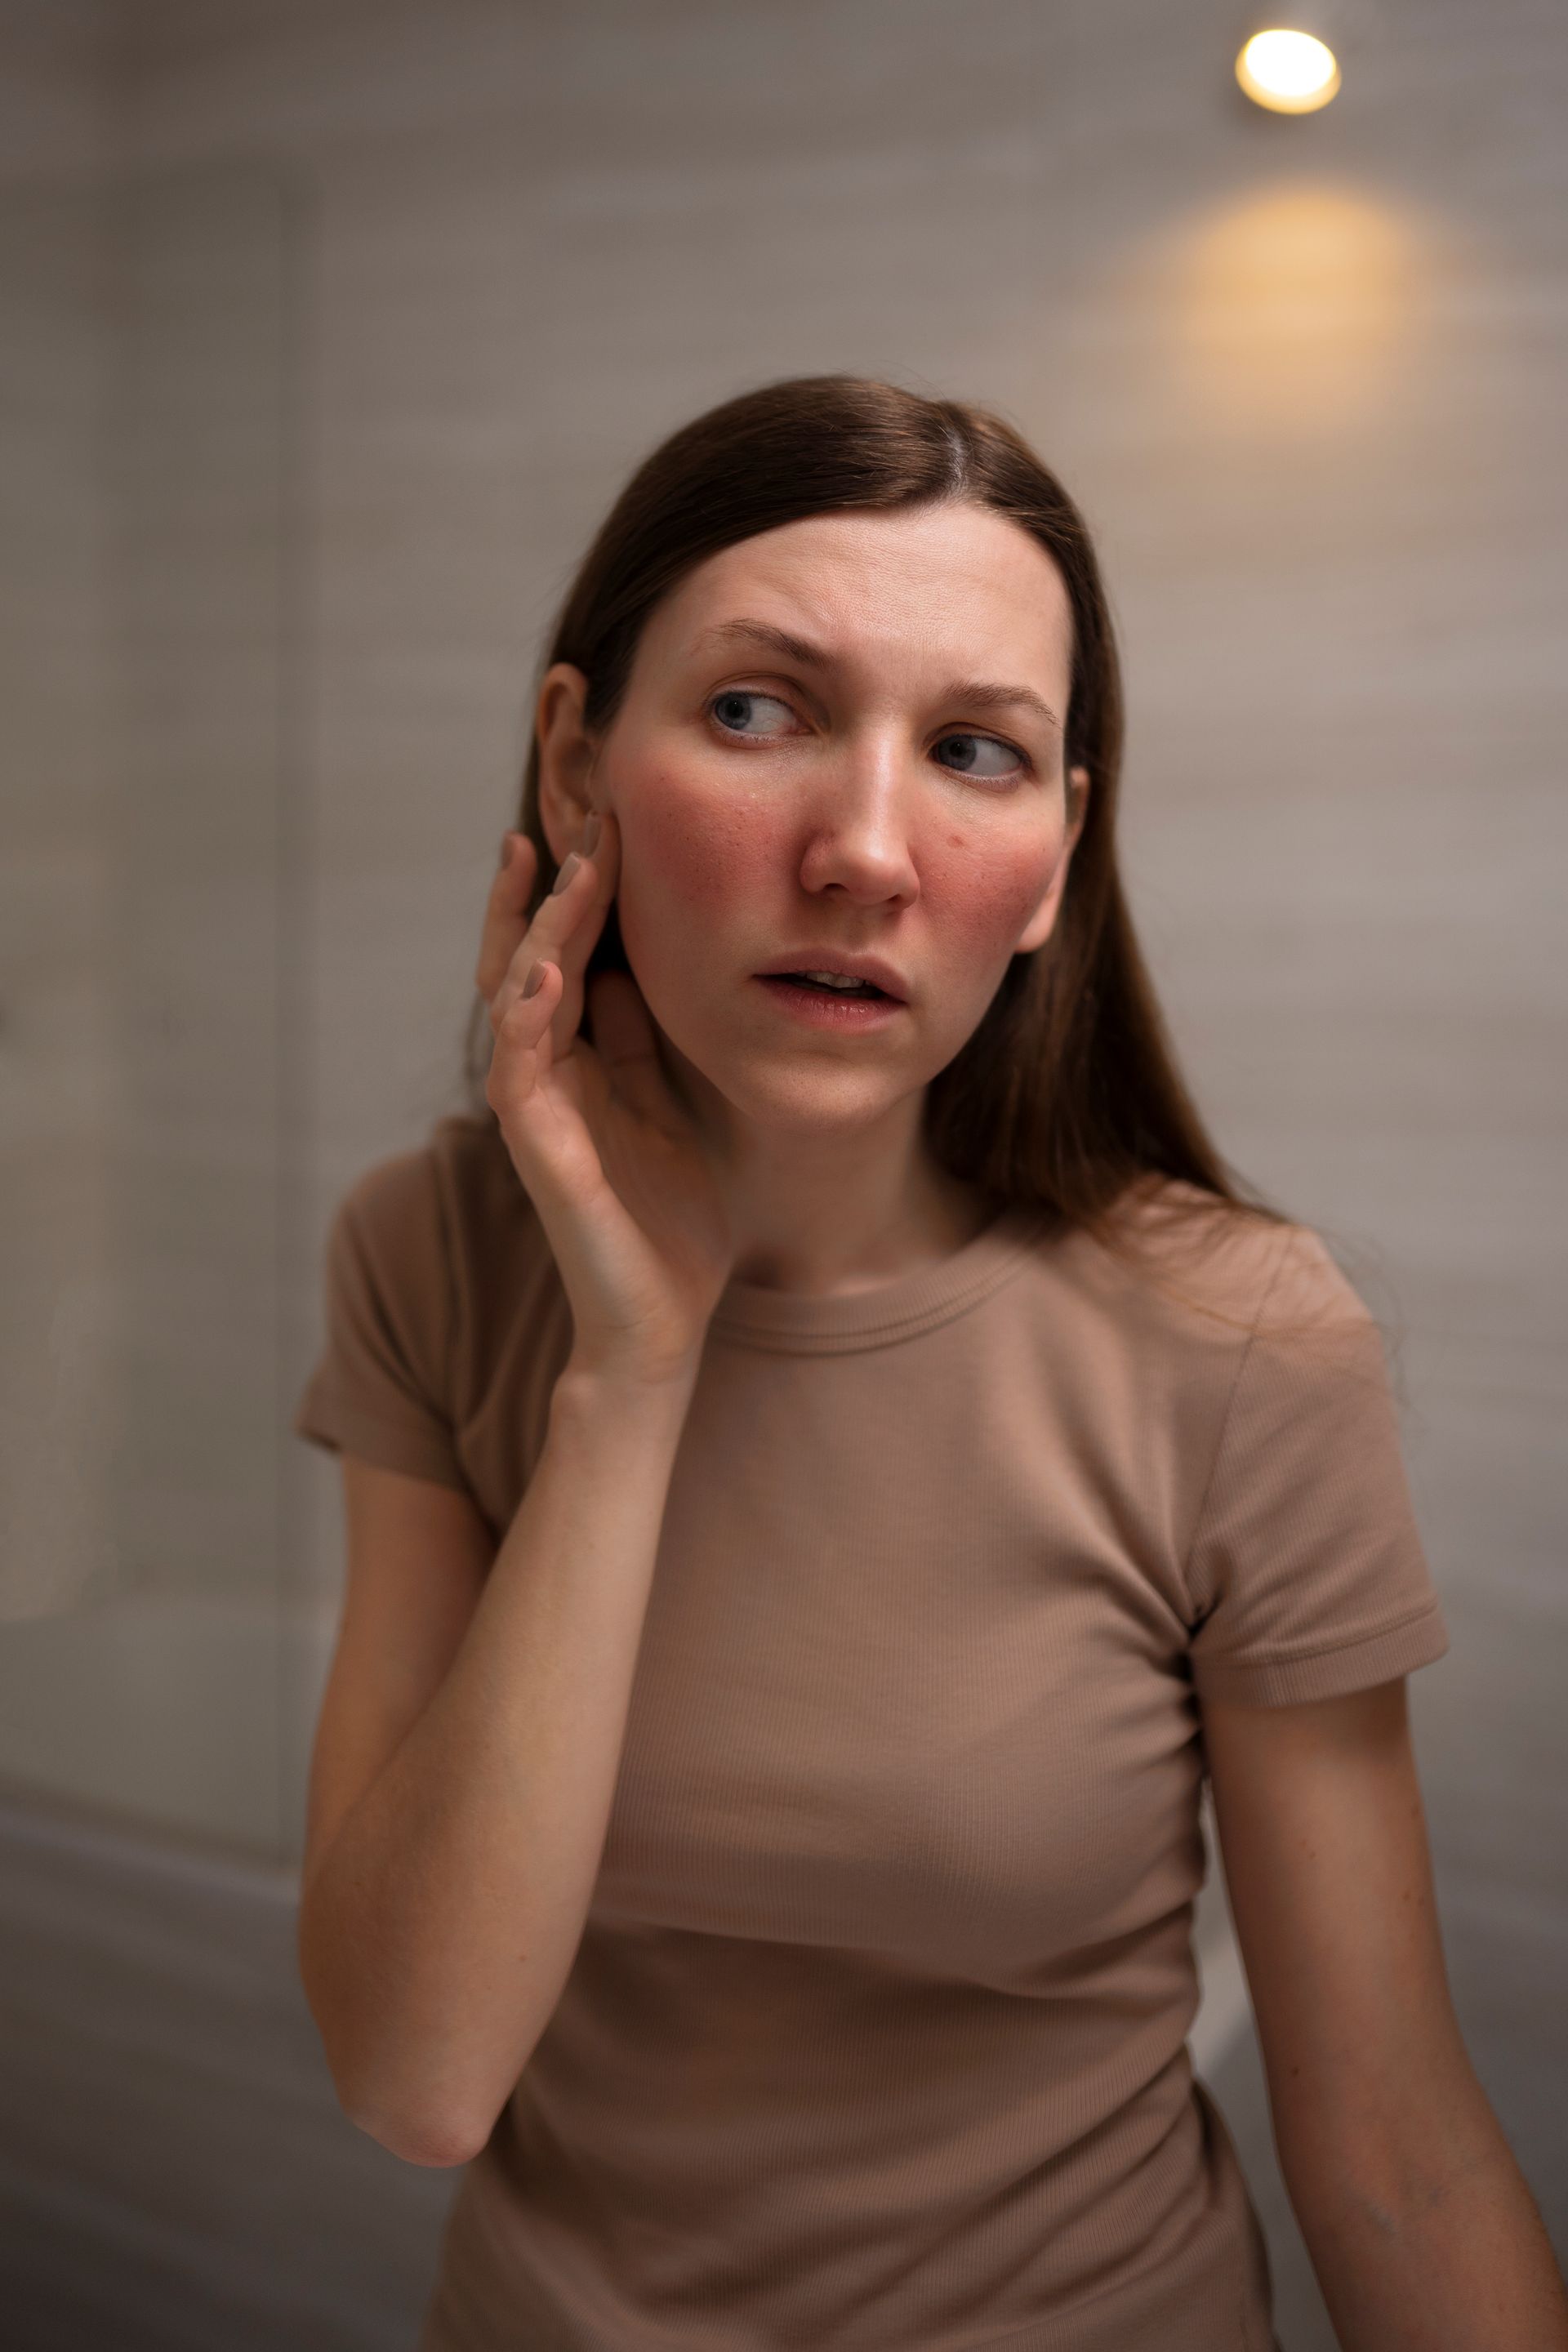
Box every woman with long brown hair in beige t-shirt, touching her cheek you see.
[296,376,1568,2352]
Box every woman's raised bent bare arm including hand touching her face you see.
[299,800,733,2164]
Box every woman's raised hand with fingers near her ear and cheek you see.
[474,812,733,1383]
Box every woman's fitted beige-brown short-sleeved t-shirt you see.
[294,1120,1448,2352]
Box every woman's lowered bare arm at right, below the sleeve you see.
[1204,1675,1568,2352]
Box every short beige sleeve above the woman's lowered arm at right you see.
[1187,1225,1448,1705]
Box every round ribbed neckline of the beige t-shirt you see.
[707,1206,1049,1355]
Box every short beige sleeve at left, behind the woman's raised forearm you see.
[292,1150,468,1486]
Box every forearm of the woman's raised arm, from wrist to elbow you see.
[301,1371,688,2164]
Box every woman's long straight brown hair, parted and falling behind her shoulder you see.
[463,374,1293,1316]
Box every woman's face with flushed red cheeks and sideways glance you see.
[541,503,1089,1131]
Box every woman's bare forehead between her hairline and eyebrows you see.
[644,503,1072,692]
